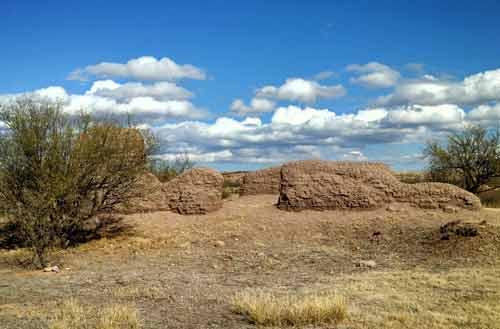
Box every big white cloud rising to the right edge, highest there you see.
[377,69,500,106]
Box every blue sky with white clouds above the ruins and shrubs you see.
[0,0,500,170]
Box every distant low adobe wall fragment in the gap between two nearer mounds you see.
[240,167,281,195]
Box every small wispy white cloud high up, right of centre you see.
[347,62,401,88]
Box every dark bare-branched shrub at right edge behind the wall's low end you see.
[424,126,500,193]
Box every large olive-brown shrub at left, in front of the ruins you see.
[0,99,154,267]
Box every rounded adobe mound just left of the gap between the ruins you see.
[164,168,224,215]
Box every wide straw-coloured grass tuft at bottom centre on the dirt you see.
[231,290,347,326]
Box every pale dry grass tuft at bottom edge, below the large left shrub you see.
[49,299,140,329]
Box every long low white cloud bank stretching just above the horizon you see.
[150,106,463,163]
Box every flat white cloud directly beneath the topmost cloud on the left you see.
[86,80,193,100]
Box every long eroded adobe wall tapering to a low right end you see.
[278,160,481,210]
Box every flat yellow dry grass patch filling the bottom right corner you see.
[336,268,500,329]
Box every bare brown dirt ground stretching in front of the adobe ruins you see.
[0,195,500,329]
